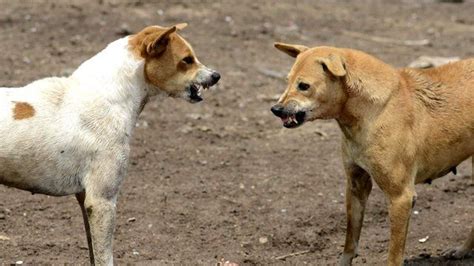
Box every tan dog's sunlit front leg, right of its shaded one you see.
[388,189,415,266]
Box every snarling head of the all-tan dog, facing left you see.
[271,43,347,128]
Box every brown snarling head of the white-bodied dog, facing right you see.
[129,23,220,103]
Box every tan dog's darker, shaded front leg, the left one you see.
[340,165,372,265]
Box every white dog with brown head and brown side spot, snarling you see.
[0,24,220,265]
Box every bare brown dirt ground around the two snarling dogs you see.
[0,0,474,265]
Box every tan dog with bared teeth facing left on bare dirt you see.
[272,43,474,265]
